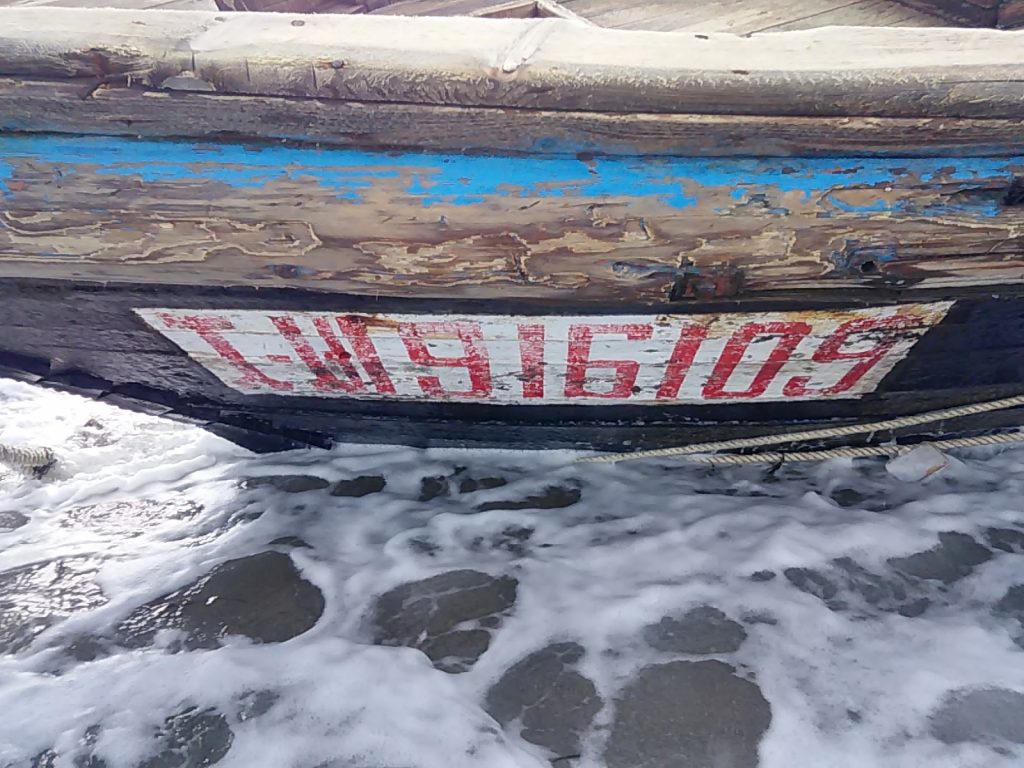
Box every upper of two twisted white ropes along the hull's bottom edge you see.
[575,395,1024,464]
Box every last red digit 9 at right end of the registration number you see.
[782,314,918,397]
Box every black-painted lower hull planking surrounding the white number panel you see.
[0,280,1024,449]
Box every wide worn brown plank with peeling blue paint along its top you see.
[0,136,1024,303]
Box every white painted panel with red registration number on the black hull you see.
[135,302,952,406]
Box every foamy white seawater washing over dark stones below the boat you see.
[0,381,1024,768]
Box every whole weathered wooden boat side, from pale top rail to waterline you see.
[0,9,1024,450]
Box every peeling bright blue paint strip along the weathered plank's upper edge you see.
[0,135,1024,216]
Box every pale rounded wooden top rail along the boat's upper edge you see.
[0,8,1024,118]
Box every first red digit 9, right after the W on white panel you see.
[398,322,490,397]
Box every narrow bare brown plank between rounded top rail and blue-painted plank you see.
[0,78,1024,157]
